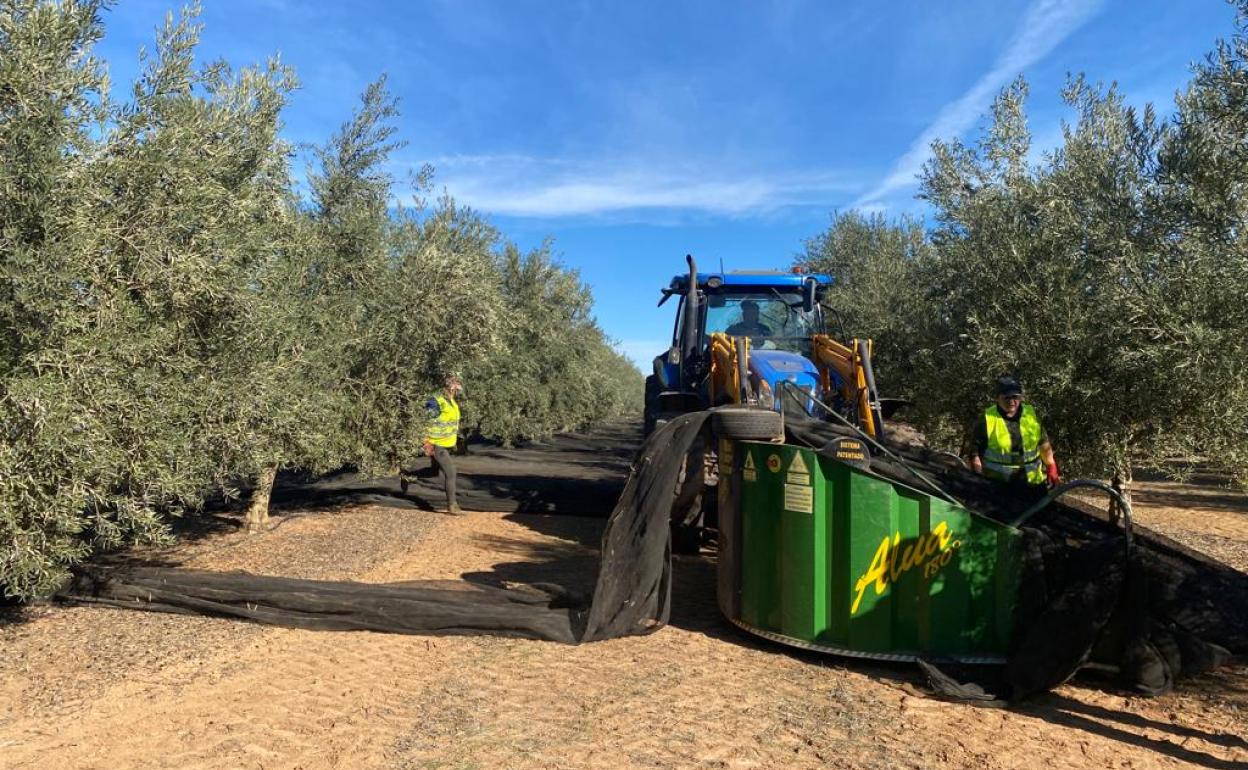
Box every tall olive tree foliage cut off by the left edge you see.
[0,0,113,593]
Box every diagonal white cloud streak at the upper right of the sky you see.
[852,0,1103,208]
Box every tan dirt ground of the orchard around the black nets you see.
[0,431,1248,770]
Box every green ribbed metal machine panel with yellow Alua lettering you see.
[719,442,1021,660]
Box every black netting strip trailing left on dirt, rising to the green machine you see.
[68,413,708,643]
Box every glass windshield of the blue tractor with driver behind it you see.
[706,291,824,354]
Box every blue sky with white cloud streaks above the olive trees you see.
[97,0,1234,371]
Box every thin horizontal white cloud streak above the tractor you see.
[399,155,861,217]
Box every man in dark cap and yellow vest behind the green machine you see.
[971,376,1062,487]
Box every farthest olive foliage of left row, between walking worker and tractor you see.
[466,243,643,442]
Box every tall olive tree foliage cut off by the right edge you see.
[1158,0,1248,485]
